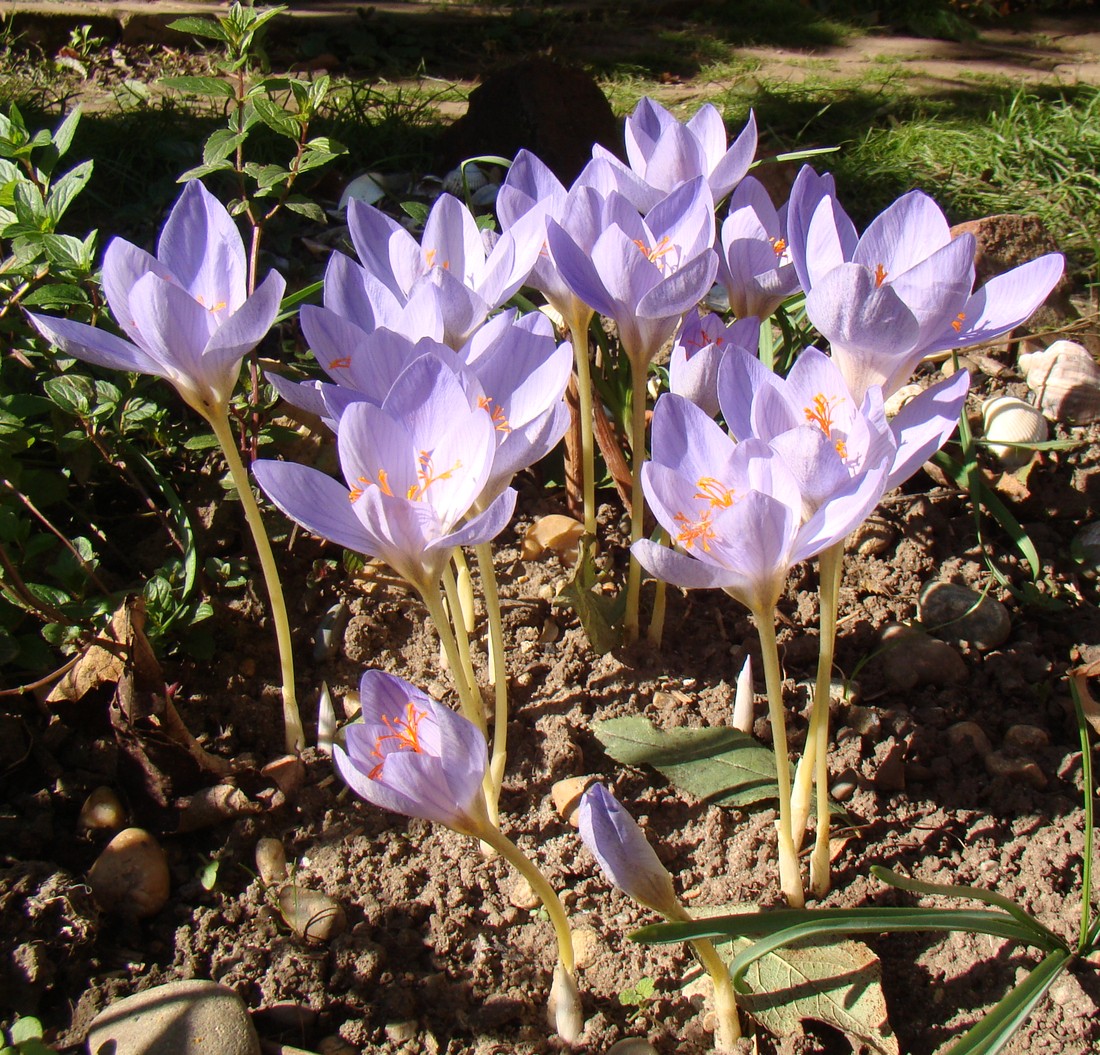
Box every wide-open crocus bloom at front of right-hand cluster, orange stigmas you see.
[631,393,889,614]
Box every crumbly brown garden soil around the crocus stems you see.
[0,6,1100,1055]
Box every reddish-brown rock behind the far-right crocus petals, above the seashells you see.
[952,212,1079,345]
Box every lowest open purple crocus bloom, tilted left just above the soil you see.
[332,670,488,835]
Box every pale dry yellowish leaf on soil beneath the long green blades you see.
[733,938,899,1055]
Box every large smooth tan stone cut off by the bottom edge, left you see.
[88,979,260,1055]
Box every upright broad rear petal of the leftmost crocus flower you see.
[156,179,248,311]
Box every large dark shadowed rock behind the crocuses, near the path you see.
[439,57,622,187]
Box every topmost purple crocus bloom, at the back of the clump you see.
[592,98,757,212]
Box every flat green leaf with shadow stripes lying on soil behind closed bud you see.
[593,716,779,806]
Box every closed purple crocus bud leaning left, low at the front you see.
[576,784,683,916]
